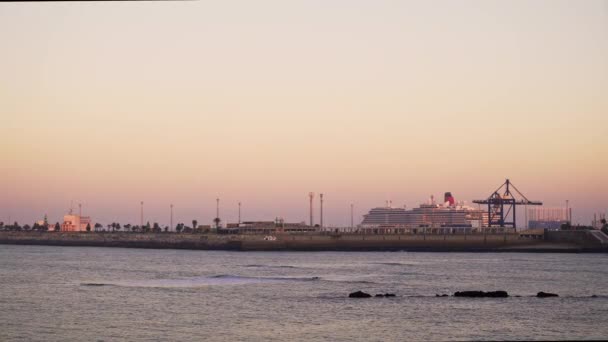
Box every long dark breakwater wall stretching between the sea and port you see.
[0,231,608,252]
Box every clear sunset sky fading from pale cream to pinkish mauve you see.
[0,0,608,226]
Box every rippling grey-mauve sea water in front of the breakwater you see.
[0,245,608,341]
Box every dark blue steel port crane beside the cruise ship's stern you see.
[473,179,543,229]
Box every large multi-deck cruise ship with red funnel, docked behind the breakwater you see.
[359,192,488,229]
